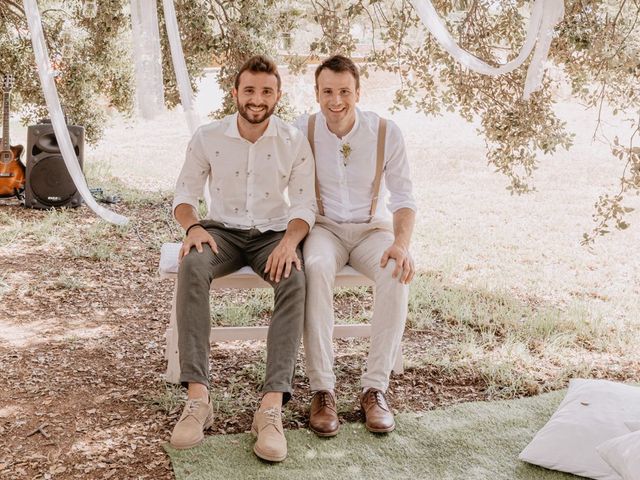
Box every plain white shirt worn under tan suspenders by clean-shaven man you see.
[295,109,417,223]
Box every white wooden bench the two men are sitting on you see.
[160,243,403,383]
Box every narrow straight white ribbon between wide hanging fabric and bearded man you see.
[162,0,200,135]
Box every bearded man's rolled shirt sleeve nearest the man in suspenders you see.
[288,135,317,229]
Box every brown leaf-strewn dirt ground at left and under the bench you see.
[0,204,486,479]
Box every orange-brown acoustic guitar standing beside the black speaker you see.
[0,75,25,198]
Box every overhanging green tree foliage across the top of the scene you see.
[0,0,640,243]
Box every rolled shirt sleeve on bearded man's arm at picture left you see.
[172,128,211,215]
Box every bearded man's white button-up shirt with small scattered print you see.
[173,113,316,232]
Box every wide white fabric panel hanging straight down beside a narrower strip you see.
[131,0,164,119]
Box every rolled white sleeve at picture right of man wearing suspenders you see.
[384,120,418,213]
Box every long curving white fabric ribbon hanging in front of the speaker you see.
[24,0,129,225]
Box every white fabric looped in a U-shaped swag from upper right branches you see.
[411,0,564,99]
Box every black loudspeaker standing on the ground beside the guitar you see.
[24,123,84,208]
